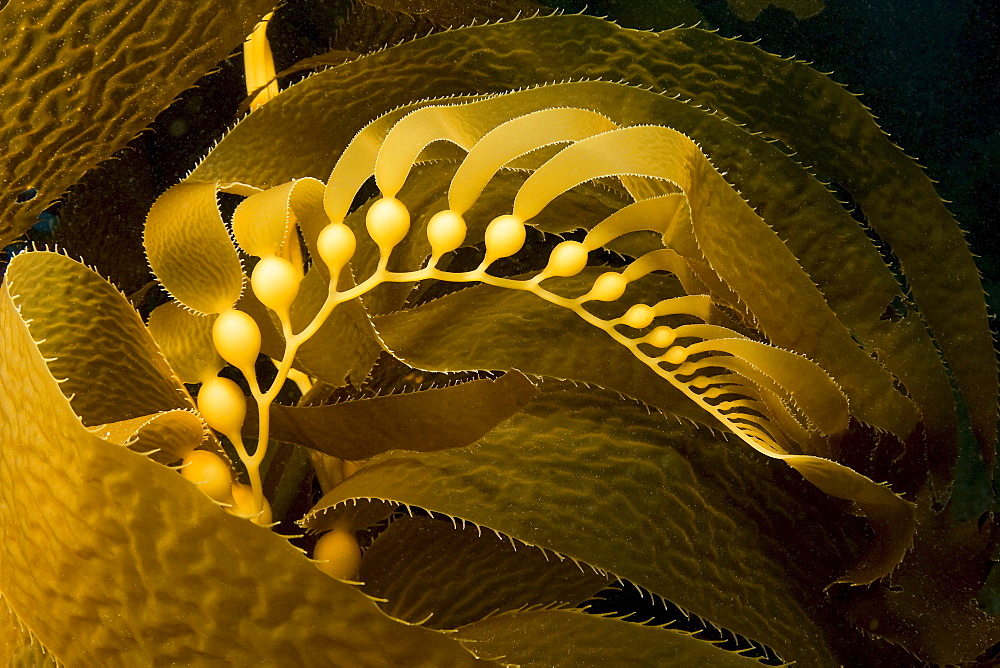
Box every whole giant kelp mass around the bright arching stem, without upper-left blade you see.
[0,2,1000,665]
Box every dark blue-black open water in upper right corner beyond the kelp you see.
[546,0,1000,320]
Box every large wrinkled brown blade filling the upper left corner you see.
[0,0,273,247]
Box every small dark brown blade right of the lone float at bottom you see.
[358,516,609,629]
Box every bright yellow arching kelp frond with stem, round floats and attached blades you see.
[162,69,916,584]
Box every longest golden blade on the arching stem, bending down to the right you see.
[514,121,916,438]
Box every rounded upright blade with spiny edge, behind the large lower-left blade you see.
[6,251,194,426]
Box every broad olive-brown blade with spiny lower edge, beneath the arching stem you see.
[305,383,836,666]
